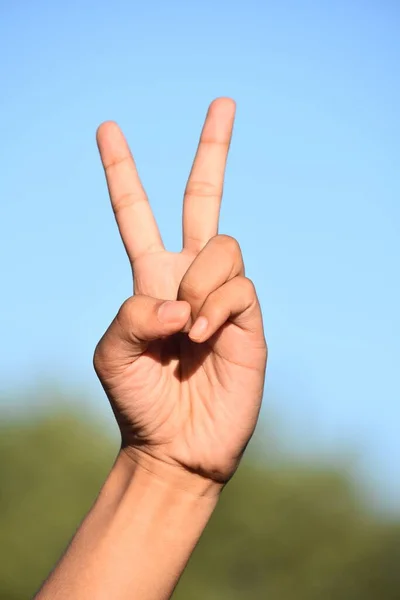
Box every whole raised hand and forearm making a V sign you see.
[37,98,267,600]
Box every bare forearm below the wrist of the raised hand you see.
[36,452,219,600]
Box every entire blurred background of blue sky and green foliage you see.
[0,0,400,600]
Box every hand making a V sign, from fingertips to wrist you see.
[94,98,267,492]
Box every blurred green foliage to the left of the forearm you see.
[0,413,115,600]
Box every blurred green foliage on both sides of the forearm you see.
[0,398,400,600]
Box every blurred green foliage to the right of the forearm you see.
[176,464,400,600]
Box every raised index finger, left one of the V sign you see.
[97,121,164,264]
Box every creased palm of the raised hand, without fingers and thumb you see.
[95,99,266,479]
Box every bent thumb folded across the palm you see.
[94,295,191,371]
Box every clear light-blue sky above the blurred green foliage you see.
[0,0,400,502]
